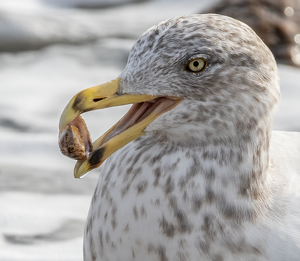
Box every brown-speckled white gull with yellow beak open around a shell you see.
[60,14,300,261]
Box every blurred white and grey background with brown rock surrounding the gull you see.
[0,0,300,261]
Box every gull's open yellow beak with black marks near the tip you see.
[59,78,181,178]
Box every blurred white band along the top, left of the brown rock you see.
[0,0,216,51]
